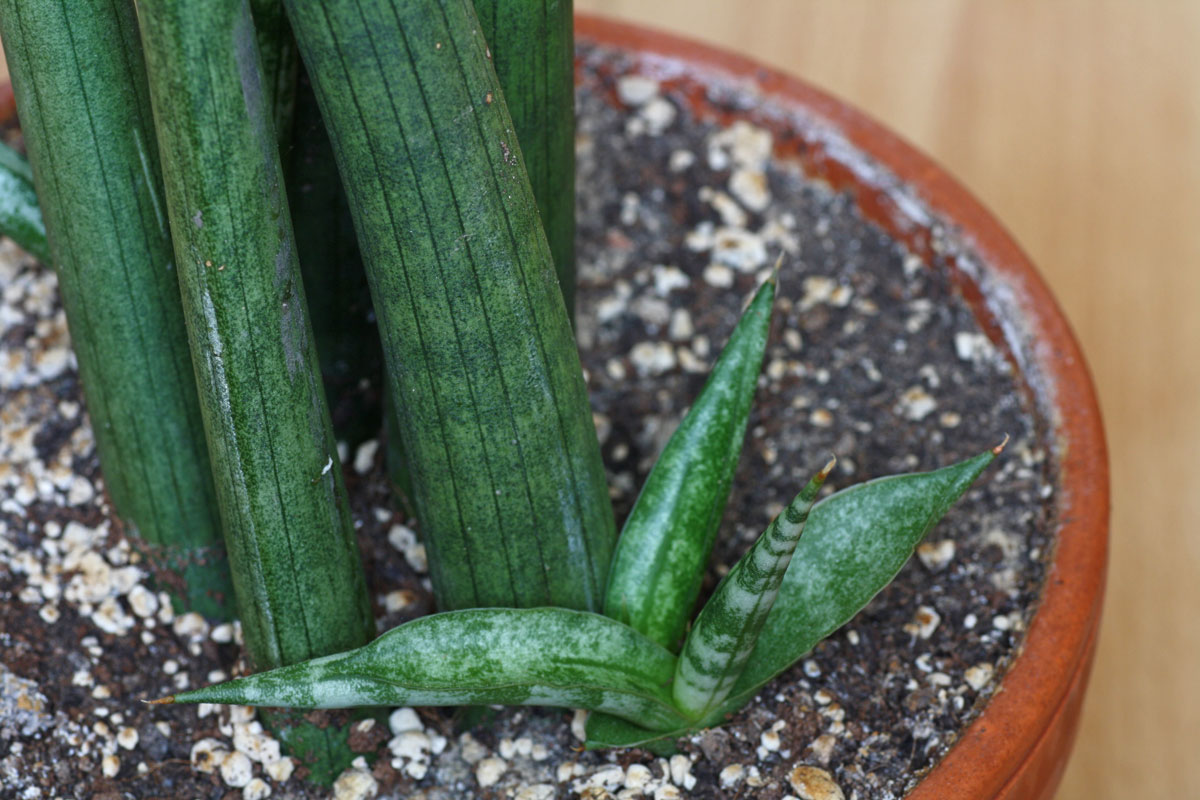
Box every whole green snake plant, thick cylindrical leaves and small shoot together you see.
[0,0,1001,780]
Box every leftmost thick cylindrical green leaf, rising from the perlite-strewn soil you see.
[0,0,230,615]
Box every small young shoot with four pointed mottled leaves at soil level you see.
[155,276,1003,750]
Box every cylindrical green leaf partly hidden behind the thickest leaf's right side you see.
[475,0,575,319]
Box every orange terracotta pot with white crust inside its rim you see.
[576,16,1109,800]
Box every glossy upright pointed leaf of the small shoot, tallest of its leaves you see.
[605,276,776,648]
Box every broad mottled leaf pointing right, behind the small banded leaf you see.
[707,439,1007,724]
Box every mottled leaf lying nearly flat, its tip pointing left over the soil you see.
[163,608,686,730]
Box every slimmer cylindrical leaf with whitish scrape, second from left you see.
[138,0,372,668]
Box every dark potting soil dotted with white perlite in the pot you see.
[0,47,1054,800]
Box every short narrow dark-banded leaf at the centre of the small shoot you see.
[672,459,836,720]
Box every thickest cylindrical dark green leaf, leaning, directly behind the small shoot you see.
[287,0,613,609]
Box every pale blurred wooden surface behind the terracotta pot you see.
[576,0,1200,800]
